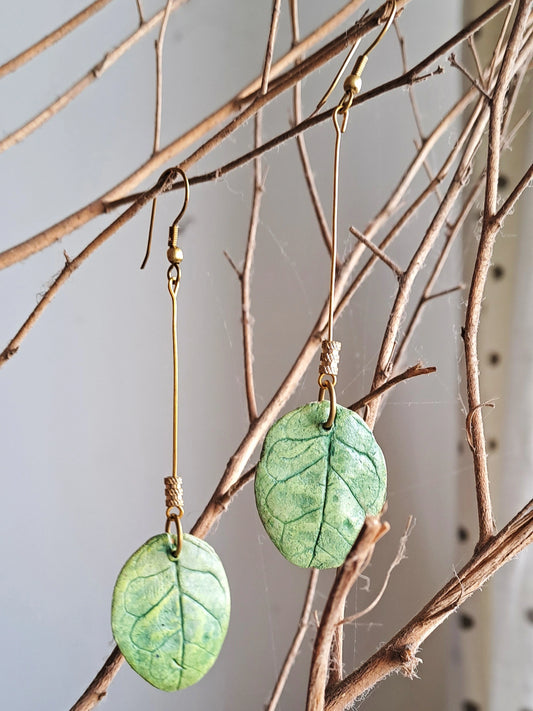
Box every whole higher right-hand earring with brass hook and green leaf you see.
[255,25,396,568]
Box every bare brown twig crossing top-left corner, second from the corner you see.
[0,0,188,153]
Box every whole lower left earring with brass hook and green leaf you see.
[111,168,230,691]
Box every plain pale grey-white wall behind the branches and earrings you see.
[0,0,474,711]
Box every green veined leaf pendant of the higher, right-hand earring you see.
[255,401,387,568]
